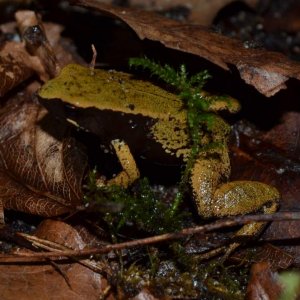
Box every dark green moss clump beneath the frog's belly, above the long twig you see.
[85,171,187,234]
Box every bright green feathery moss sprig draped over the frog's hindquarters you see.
[129,57,231,211]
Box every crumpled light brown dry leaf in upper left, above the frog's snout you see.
[0,11,83,97]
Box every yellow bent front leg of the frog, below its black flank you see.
[97,140,140,188]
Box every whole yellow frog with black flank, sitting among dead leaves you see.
[39,64,280,253]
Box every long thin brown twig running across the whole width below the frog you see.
[0,212,300,263]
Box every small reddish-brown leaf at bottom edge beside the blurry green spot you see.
[246,262,282,300]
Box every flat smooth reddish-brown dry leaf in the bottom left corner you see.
[0,264,103,300]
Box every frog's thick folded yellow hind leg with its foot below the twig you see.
[191,145,280,254]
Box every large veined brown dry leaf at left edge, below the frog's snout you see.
[0,90,86,221]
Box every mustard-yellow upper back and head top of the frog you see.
[39,64,186,122]
